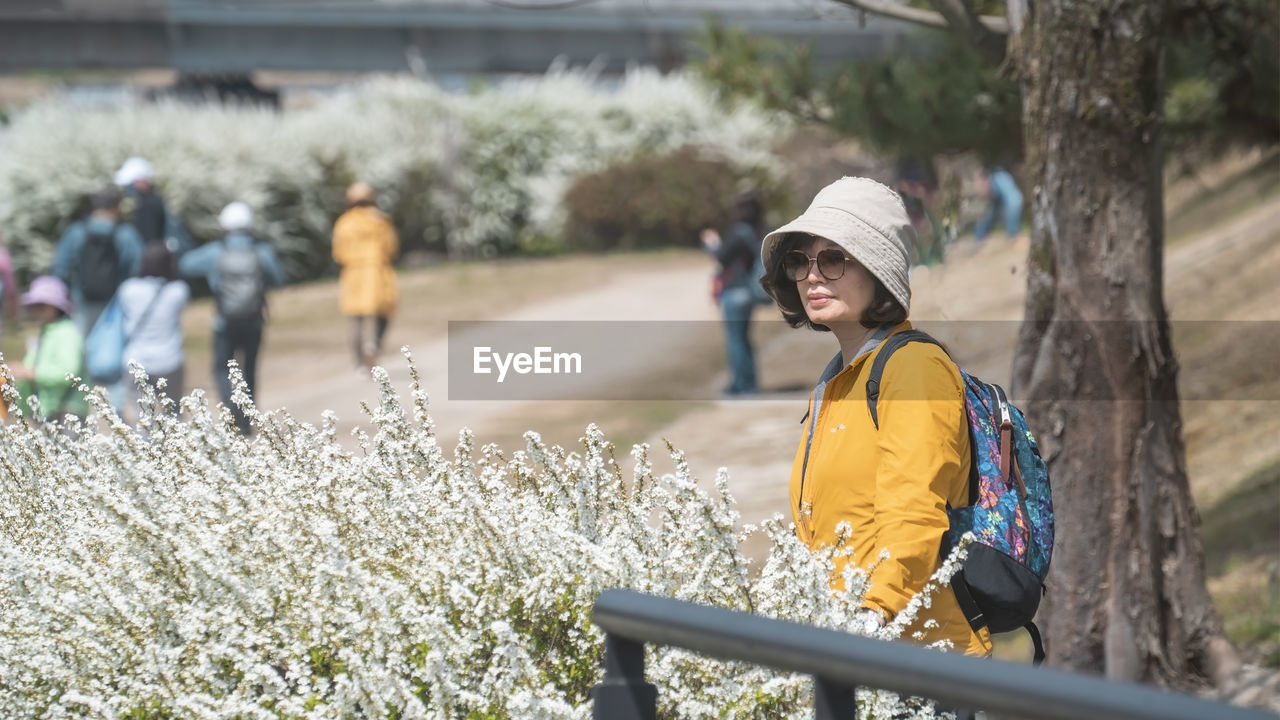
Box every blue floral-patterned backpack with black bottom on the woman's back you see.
[867,331,1053,665]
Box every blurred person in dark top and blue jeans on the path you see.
[701,191,764,396]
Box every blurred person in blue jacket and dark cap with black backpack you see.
[50,187,142,337]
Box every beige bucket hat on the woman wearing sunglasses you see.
[760,177,915,311]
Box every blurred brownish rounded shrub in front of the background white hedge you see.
[564,147,741,250]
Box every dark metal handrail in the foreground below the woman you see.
[591,589,1277,720]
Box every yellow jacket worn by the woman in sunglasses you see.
[791,323,991,655]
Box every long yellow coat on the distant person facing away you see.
[333,208,399,316]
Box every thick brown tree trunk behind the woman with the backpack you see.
[1011,0,1238,689]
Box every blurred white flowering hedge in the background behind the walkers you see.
[0,69,786,278]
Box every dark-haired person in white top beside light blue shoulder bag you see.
[118,243,191,415]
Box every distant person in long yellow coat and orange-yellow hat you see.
[333,182,399,369]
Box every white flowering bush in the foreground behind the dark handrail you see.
[0,353,950,720]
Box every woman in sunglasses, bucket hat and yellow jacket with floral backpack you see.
[762,177,1052,656]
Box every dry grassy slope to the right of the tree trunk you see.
[1166,152,1280,667]
